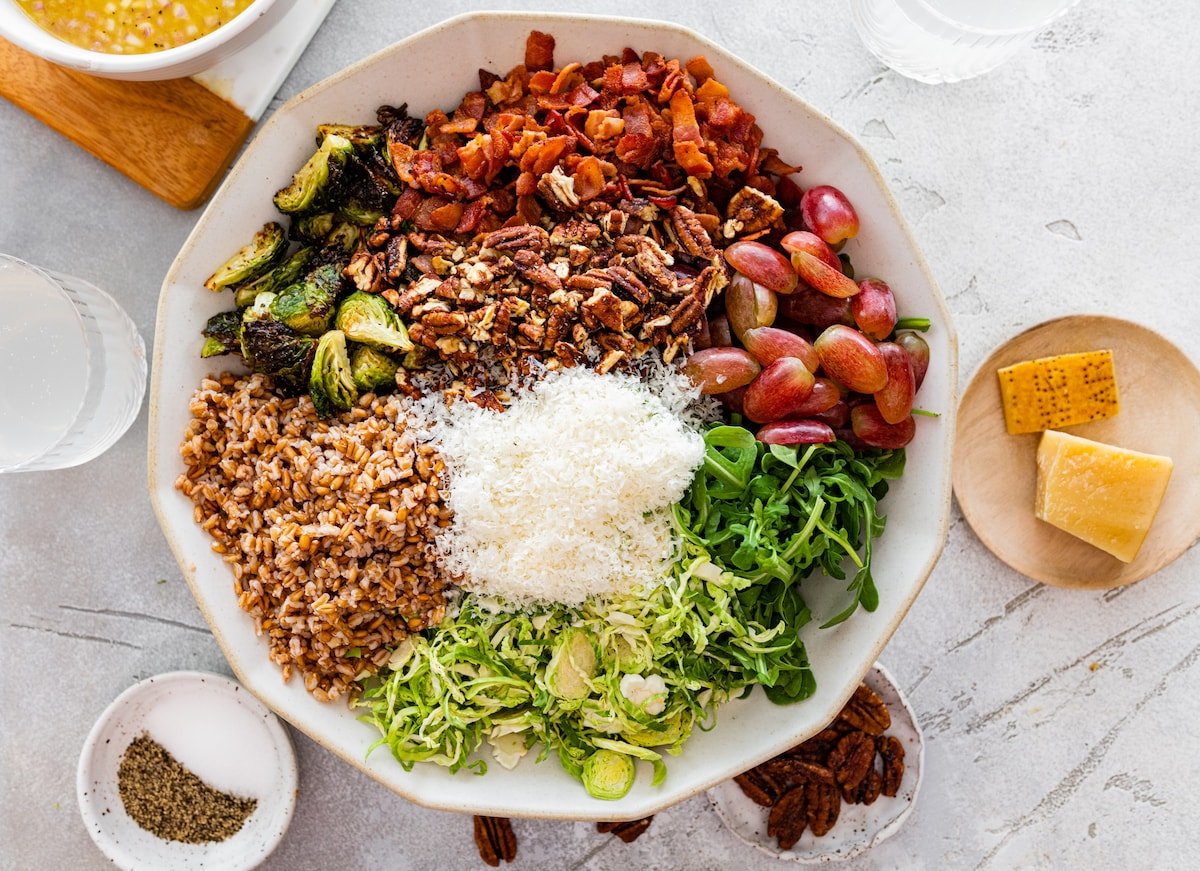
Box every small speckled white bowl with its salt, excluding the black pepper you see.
[76,672,298,871]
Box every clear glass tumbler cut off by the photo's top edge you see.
[850,0,1079,83]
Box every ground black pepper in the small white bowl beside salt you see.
[116,734,258,843]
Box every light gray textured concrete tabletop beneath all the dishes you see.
[0,0,1200,871]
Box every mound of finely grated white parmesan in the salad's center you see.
[422,364,707,606]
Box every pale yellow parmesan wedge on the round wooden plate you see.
[1034,430,1174,563]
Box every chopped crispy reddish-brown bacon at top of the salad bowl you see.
[374,31,798,242]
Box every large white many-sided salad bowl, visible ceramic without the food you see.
[149,12,958,819]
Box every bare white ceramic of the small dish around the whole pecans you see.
[708,662,925,865]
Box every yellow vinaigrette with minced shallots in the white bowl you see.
[17,0,253,54]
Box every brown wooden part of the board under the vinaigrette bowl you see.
[0,40,254,209]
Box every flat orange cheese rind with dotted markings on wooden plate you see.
[996,350,1121,436]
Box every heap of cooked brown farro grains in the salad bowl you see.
[175,374,450,701]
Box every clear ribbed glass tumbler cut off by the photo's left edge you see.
[0,254,146,473]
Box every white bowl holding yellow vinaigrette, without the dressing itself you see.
[0,0,296,82]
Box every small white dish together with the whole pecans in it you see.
[708,662,925,864]
